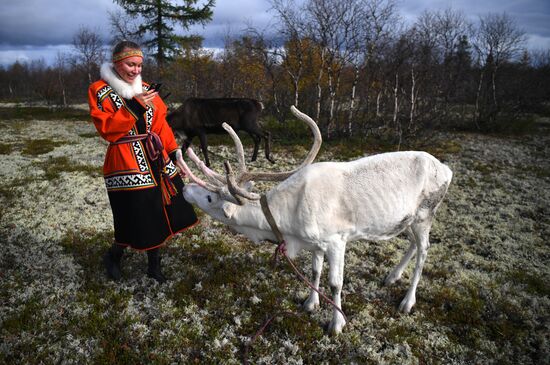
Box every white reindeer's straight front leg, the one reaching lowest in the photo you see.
[327,242,346,335]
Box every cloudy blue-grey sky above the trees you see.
[0,0,550,65]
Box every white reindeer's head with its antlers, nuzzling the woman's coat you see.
[176,106,322,220]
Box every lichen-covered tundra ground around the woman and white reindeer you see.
[0,109,550,364]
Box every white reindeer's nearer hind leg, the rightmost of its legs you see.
[399,219,432,313]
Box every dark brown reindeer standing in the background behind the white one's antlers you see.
[166,98,274,166]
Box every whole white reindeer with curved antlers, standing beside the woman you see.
[178,107,452,334]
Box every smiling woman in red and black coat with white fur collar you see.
[88,41,197,283]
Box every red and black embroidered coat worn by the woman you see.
[88,80,197,250]
